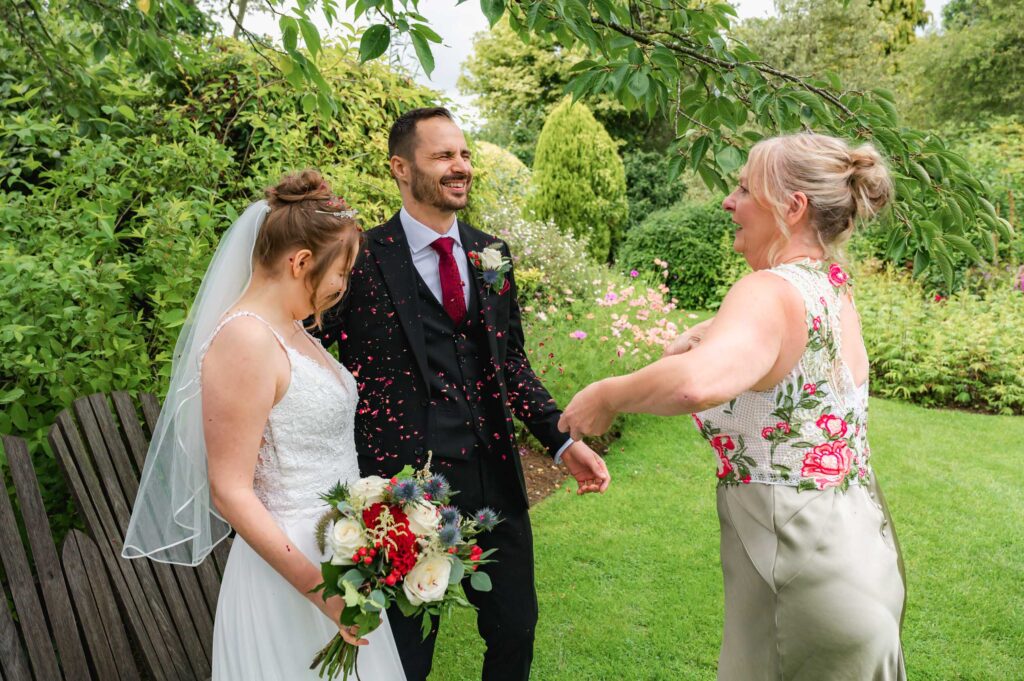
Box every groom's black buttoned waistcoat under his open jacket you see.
[416,275,505,459]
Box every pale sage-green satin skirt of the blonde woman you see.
[718,483,906,681]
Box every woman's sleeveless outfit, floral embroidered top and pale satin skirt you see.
[693,262,906,681]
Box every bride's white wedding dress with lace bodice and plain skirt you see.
[211,311,406,681]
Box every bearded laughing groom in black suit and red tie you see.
[323,108,610,681]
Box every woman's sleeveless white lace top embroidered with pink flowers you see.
[693,262,870,490]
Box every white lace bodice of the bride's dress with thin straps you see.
[202,311,359,519]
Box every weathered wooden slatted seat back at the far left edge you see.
[0,435,141,681]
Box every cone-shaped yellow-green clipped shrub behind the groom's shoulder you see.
[527,98,629,262]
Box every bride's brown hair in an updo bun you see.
[253,169,361,326]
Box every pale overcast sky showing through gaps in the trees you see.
[225,0,948,125]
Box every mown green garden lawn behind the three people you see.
[431,399,1024,681]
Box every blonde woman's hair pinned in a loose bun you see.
[745,133,893,265]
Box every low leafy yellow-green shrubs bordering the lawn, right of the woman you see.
[854,268,1024,414]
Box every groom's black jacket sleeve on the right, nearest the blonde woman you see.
[503,241,569,458]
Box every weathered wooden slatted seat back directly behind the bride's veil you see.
[49,392,228,681]
